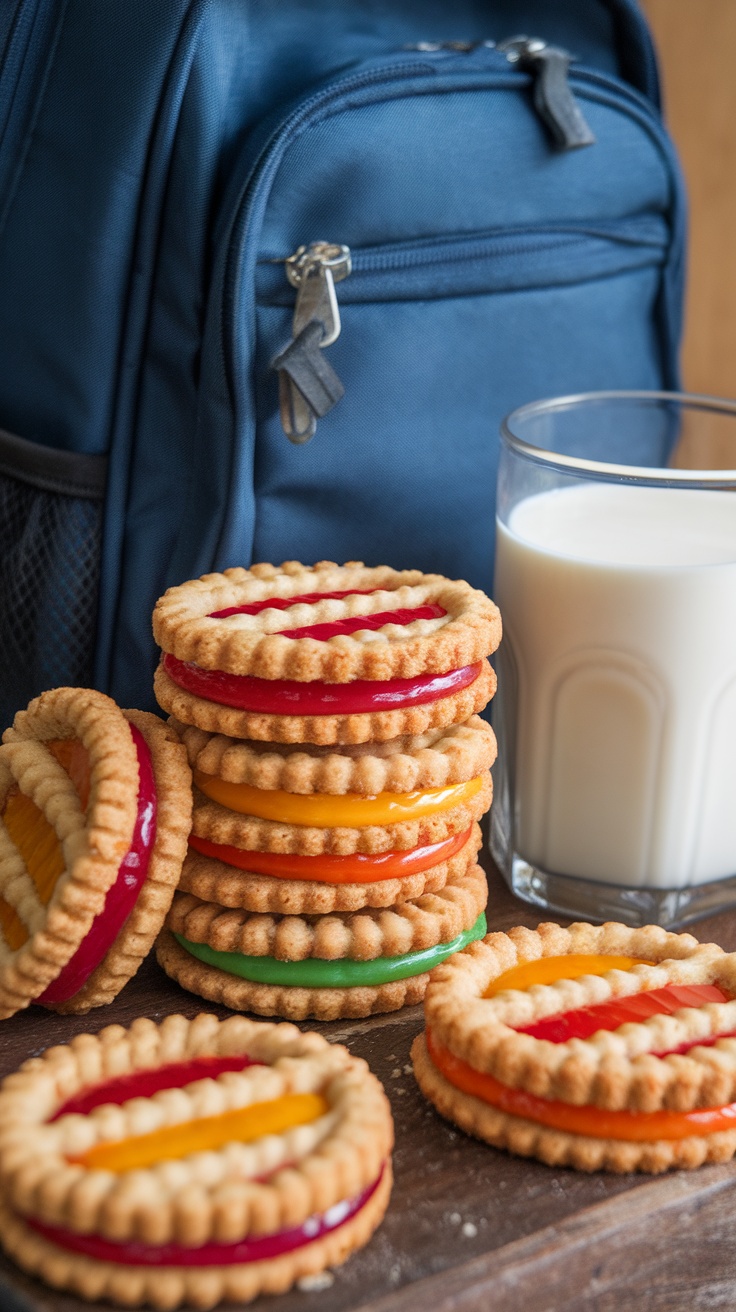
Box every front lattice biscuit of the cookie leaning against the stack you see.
[0,689,138,1015]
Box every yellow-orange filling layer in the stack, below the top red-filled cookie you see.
[194,770,483,829]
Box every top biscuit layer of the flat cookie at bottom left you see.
[0,1014,392,1246]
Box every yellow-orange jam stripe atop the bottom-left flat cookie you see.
[70,1093,329,1173]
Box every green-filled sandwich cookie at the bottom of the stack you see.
[157,866,488,1021]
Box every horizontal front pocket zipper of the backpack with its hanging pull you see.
[265,215,668,445]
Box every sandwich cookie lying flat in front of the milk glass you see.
[412,924,736,1172]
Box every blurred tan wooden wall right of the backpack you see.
[642,0,736,398]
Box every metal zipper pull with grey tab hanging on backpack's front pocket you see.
[272,241,350,445]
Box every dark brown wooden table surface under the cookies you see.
[0,850,736,1312]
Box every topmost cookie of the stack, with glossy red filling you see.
[153,562,501,744]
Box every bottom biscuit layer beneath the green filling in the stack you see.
[156,929,429,1021]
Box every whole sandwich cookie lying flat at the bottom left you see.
[0,1015,392,1312]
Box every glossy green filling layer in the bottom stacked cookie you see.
[174,912,485,988]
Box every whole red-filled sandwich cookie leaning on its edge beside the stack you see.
[0,689,192,1015]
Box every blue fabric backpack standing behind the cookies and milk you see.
[0,0,684,723]
